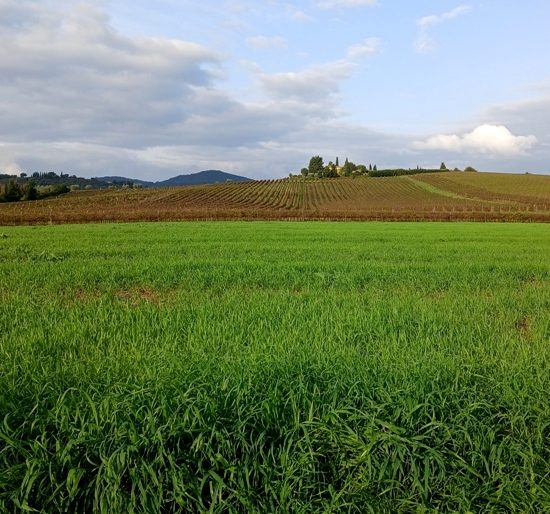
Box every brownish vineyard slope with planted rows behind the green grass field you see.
[0,172,550,225]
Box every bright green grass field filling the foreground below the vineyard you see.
[0,222,550,513]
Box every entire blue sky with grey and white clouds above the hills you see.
[0,0,550,179]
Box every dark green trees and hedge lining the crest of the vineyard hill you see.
[301,155,476,178]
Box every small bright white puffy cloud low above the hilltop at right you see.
[411,124,537,156]
